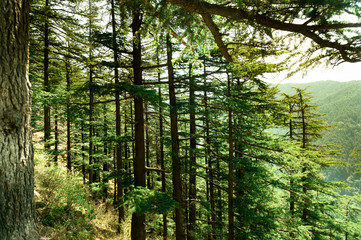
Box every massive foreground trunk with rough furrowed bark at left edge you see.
[0,0,39,240]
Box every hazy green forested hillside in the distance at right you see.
[278,81,361,183]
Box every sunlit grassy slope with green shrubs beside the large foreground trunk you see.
[34,143,131,240]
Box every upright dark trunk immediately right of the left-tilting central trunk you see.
[187,65,197,240]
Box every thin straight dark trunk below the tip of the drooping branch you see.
[228,75,234,240]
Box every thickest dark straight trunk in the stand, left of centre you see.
[131,9,145,240]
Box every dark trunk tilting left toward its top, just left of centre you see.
[167,34,185,240]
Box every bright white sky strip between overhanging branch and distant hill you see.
[263,62,361,84]
